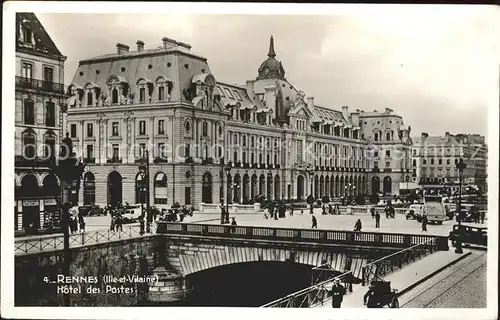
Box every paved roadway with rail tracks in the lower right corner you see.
[400,250,487,308]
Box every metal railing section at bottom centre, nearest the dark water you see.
[261,271,352,308]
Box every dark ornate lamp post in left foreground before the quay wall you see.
[50,132,85,306]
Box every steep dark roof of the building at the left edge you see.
[16,12,63,57]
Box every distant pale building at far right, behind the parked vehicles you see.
[412,132,487,192]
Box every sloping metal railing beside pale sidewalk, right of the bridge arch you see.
[361,238,439,286]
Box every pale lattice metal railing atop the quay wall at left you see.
[14,225,140,255]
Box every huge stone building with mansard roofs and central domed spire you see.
[68,37,411,206]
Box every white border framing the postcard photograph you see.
[0,1,500,320]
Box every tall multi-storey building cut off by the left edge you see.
[14,13,67,232]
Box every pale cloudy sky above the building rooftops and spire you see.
[37,6,499,135]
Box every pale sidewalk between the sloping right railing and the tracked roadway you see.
[318,250,468,308]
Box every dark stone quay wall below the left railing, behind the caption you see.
[15,236,159,306]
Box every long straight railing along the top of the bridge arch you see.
[156,221,449,251]
